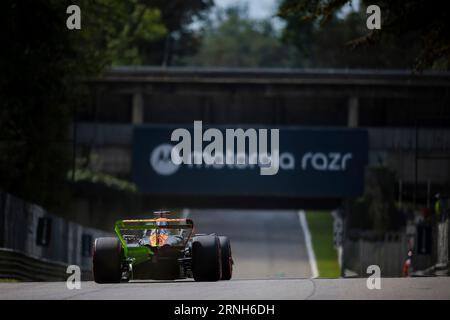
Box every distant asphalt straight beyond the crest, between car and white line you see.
[189,210,311,279]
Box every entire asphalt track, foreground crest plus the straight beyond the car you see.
[0,210,450,300]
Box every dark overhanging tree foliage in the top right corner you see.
[279,0,450,70]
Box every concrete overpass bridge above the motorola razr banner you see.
[82,67,450,127]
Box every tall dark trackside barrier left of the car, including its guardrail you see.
[0,193,111,281]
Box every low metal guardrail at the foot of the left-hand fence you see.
[0,248,92,281]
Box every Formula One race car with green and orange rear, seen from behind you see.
[92,211,233,283]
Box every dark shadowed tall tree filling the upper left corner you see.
[0,0,165,207]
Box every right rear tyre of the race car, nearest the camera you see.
[192,235,222,281]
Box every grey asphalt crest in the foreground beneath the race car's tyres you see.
[0,278,450,300]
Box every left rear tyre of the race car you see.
[92,238,122,283]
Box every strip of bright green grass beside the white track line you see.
[305,211,341,278]
